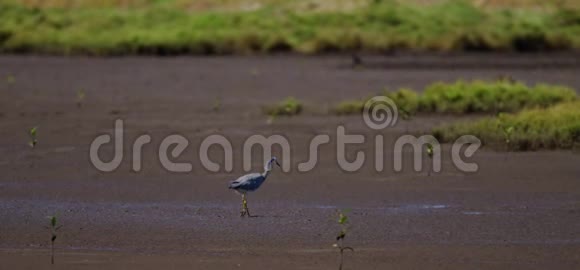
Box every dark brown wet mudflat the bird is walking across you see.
[0,54,580,269]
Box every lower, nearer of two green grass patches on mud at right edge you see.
[433,101,580,151]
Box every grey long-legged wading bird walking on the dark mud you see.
[229,157,280,217]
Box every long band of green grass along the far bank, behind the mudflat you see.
[0,0,580,55]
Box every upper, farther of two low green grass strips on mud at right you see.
[332,80,578,115]
